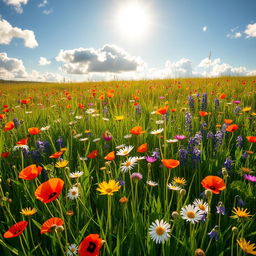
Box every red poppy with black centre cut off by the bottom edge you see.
[78,234,102,256]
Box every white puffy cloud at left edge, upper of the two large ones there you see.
[0,19,38,48]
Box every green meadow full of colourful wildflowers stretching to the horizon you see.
[0,77,256,256]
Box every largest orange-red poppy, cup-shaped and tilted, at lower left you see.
[35,178,64,203]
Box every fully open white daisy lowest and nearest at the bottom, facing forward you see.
[149,220,171,244]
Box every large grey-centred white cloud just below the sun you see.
[56,44,145,74]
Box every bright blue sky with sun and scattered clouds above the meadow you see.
[0,0,256,81]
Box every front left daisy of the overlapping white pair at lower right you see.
[180,204,204,224]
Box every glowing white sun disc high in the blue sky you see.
[116,2,150,40]
